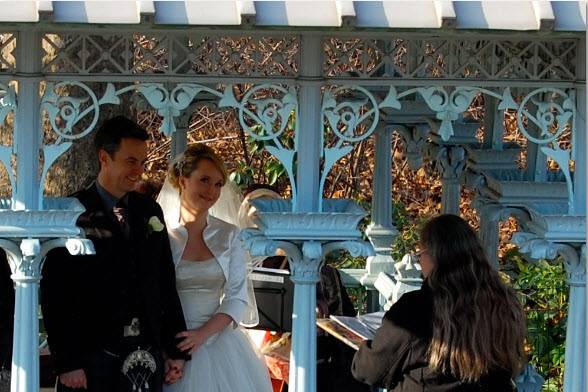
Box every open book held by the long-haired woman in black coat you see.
[316,312,384,350]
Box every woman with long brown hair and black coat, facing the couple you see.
[352,215,526,392]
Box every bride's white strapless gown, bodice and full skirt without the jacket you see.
[165,258,272,392]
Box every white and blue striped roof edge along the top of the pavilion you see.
[0,0,587,31]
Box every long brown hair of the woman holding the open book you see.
[421,215,526,382]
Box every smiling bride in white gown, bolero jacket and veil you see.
[158,144,272,392]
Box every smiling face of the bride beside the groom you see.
[179,159,224,212]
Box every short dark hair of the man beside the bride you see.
[94,116,149,157]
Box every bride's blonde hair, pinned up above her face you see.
[167,144,227,191]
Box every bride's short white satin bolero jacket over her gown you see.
[168,215,247,327]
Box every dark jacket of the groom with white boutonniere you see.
[41,184,186,374]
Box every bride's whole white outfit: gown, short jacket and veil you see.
[157,179,272,392]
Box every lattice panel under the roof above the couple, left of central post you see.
[43,33,299,77]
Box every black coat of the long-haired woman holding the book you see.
[351,282,513,392]
